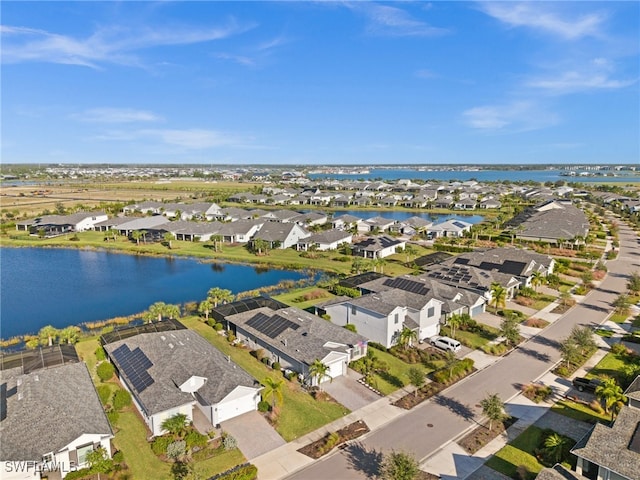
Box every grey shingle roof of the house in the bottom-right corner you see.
[571,407,640,480]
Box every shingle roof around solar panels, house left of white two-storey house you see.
[227,307,367,365]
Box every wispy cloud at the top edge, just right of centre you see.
[346,2,448,37]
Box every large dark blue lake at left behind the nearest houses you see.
[0,248,304,338]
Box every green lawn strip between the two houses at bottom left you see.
[113,411,171,480]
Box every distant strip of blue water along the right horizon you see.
[309,168,640,183]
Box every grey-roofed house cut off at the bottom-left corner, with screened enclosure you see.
[0,345,113,480]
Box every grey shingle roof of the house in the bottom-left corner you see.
[0,363,113,461]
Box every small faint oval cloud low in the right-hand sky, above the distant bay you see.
[462,101,558,133]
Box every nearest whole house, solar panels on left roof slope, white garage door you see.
[100,320,261,436]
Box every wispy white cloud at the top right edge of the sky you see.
[480,2,607,40]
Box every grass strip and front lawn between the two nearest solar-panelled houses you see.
[181,317,349,441]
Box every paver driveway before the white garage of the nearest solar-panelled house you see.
[220,412,287,460]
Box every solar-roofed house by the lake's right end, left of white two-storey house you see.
[212,298,367,385]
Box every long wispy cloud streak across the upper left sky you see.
[0,19,253,69]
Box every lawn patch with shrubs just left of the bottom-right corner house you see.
[486,425,544,479]
